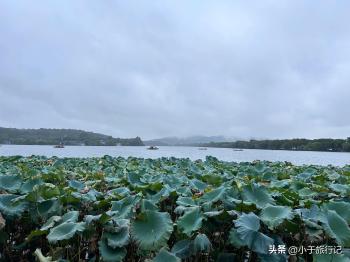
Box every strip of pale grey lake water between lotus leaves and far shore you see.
[0,145,350,166]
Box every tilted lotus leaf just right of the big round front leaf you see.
[177,207,204,236]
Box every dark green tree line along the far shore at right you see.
[200,137,350,152]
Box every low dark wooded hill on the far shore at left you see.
[0,127,144,146]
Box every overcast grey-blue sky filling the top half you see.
[0,0,350,139]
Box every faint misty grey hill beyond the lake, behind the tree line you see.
[144,136,232,146]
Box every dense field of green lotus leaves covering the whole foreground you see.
[0,156,350,262]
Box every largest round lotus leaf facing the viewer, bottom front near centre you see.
[131,210,173,250]
